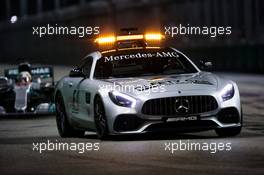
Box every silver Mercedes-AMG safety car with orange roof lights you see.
[55,31,242,138]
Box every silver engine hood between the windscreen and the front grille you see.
[100,72,219,94]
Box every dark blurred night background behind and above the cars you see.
[0,0,264,73]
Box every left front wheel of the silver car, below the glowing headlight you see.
[94,96,108,139]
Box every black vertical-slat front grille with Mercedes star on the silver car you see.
[142,95,218,116]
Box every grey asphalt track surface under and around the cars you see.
[0,67,264,175]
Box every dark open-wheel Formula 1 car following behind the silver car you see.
[0,63,55,115]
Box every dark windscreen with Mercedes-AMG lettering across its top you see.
[94,49,197,79]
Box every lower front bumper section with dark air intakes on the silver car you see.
[113,107,241,134]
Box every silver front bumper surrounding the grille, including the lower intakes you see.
[101,86,242,134]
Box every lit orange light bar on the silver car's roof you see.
[95,33,164,44]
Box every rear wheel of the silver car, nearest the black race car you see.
[55,93,85,137]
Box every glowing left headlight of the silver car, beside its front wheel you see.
[109,91,137,108]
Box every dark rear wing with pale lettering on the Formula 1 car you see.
[5,66,54,84]
